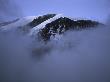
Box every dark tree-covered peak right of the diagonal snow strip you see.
[39,17,99,41]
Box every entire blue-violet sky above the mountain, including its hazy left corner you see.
[0,0,110,22]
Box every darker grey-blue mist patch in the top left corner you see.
[0,0,23,22]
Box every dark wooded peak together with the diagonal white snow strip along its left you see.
[29,14,102,41]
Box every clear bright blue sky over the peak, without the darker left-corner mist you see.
[15,0,109,21]
